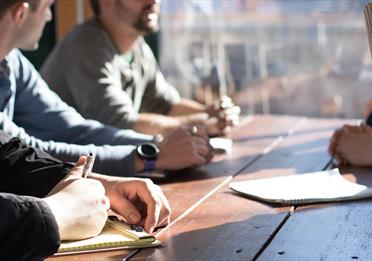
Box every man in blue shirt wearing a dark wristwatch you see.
[0,0,211,176]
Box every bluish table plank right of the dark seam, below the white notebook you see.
[259,167,372,260]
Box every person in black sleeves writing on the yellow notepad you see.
[0,132,170,260]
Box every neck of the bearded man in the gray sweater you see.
[98,17,141,53]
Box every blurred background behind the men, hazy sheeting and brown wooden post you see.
[26,0,372,118]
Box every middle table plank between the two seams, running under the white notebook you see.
[134,119,343,260]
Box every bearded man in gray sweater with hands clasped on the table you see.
[41,0,240,135]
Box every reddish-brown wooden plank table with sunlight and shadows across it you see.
[50,116,372,260]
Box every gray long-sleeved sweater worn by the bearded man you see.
[41,18,180,128]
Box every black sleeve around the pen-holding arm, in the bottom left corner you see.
[0,192,60,260]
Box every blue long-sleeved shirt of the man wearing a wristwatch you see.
[0,49,152,176]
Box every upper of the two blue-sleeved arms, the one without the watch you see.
[11,51,153,145]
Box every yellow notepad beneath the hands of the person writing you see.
[55,217,161,255]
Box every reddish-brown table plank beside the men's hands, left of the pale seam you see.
[160,116,301,220]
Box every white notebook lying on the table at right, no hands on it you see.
[230,169,372,205]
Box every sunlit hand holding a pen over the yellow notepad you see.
[43,157,110,240]
